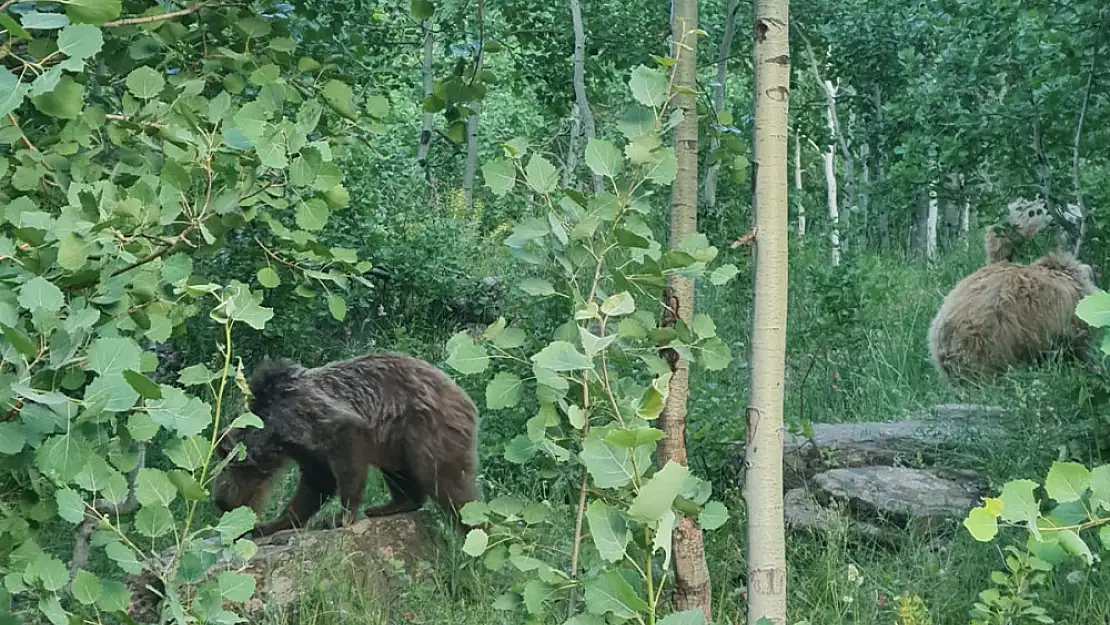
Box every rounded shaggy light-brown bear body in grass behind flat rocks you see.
[929,253,1094,380]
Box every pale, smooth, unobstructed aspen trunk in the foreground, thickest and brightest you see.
[744,0,790,625]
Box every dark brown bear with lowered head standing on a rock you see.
[212,354,477,537]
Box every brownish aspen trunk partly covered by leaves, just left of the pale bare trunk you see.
[658,0,712,623]
